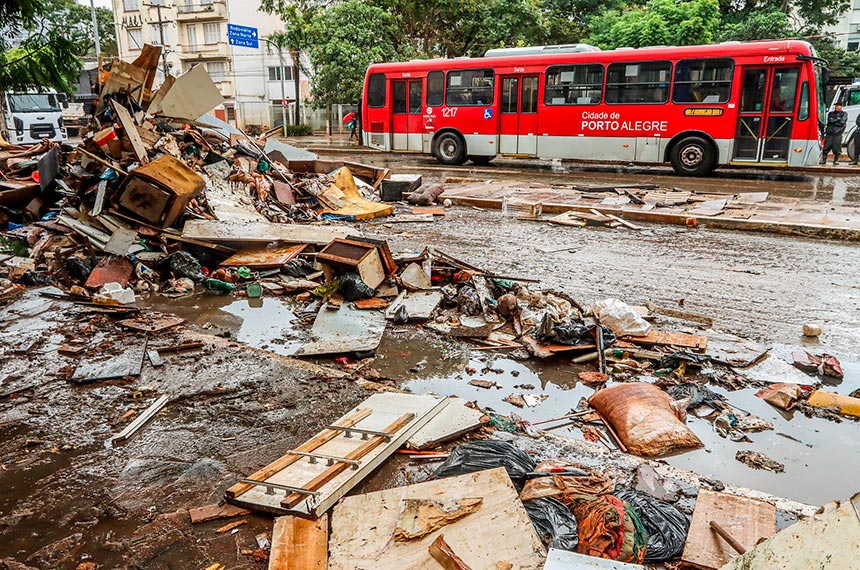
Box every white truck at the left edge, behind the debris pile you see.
[2,90,68,144]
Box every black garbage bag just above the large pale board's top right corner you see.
[433,441,537,490]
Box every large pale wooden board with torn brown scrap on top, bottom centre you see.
[329,468,544,570]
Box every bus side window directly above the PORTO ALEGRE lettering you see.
[606,61,672,103]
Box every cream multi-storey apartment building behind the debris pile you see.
[112,0,309,128]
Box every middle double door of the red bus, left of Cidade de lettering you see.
[498,75,538,155]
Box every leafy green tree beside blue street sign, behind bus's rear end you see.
[307,0,414,108]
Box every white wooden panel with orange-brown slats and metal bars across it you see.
[226,392,448,518]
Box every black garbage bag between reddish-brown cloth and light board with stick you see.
[613,488,690,562]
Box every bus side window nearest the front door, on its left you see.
[672,59,735,104]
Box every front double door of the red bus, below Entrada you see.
[733,66,800,163]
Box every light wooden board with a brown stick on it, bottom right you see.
[681,489,776,570]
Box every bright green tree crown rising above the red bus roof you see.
[587,0,720,49]
